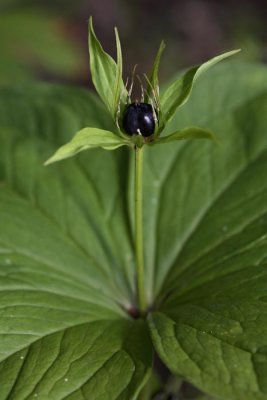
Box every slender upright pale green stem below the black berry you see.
[135,146,146,314]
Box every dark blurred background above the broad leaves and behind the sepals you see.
[0,0,267,85]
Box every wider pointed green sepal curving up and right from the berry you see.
[160,50,240,122]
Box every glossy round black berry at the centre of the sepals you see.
[122,103,155,136]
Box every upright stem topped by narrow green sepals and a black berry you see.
[46,18,239,314]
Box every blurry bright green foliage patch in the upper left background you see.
[0,8,83,83]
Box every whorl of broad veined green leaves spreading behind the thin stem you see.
[0,16,267,400]
